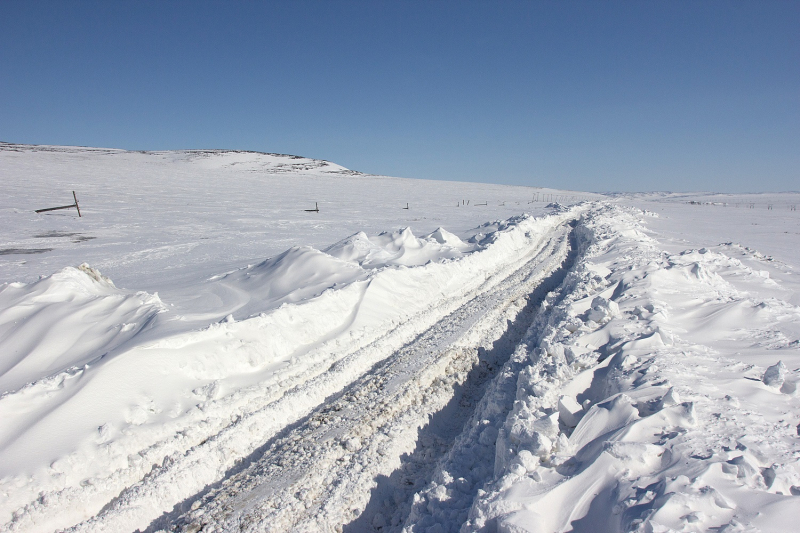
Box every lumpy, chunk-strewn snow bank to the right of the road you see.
[406,207,800,532]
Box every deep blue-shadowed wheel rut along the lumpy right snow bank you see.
[354,221,578,533]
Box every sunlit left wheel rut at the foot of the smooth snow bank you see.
[59,213,576,531]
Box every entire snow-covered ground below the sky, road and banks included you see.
[0,144,800,533]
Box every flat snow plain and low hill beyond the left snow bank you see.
[0,143,580,294]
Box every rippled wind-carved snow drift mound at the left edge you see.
[0,264,166,396]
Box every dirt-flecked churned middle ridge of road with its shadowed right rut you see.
[164,224,570,531]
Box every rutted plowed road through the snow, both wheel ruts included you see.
[56,213,582,532]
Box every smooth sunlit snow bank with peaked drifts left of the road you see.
[0,213,572,531]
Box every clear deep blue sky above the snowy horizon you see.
[0,0,800,192]
